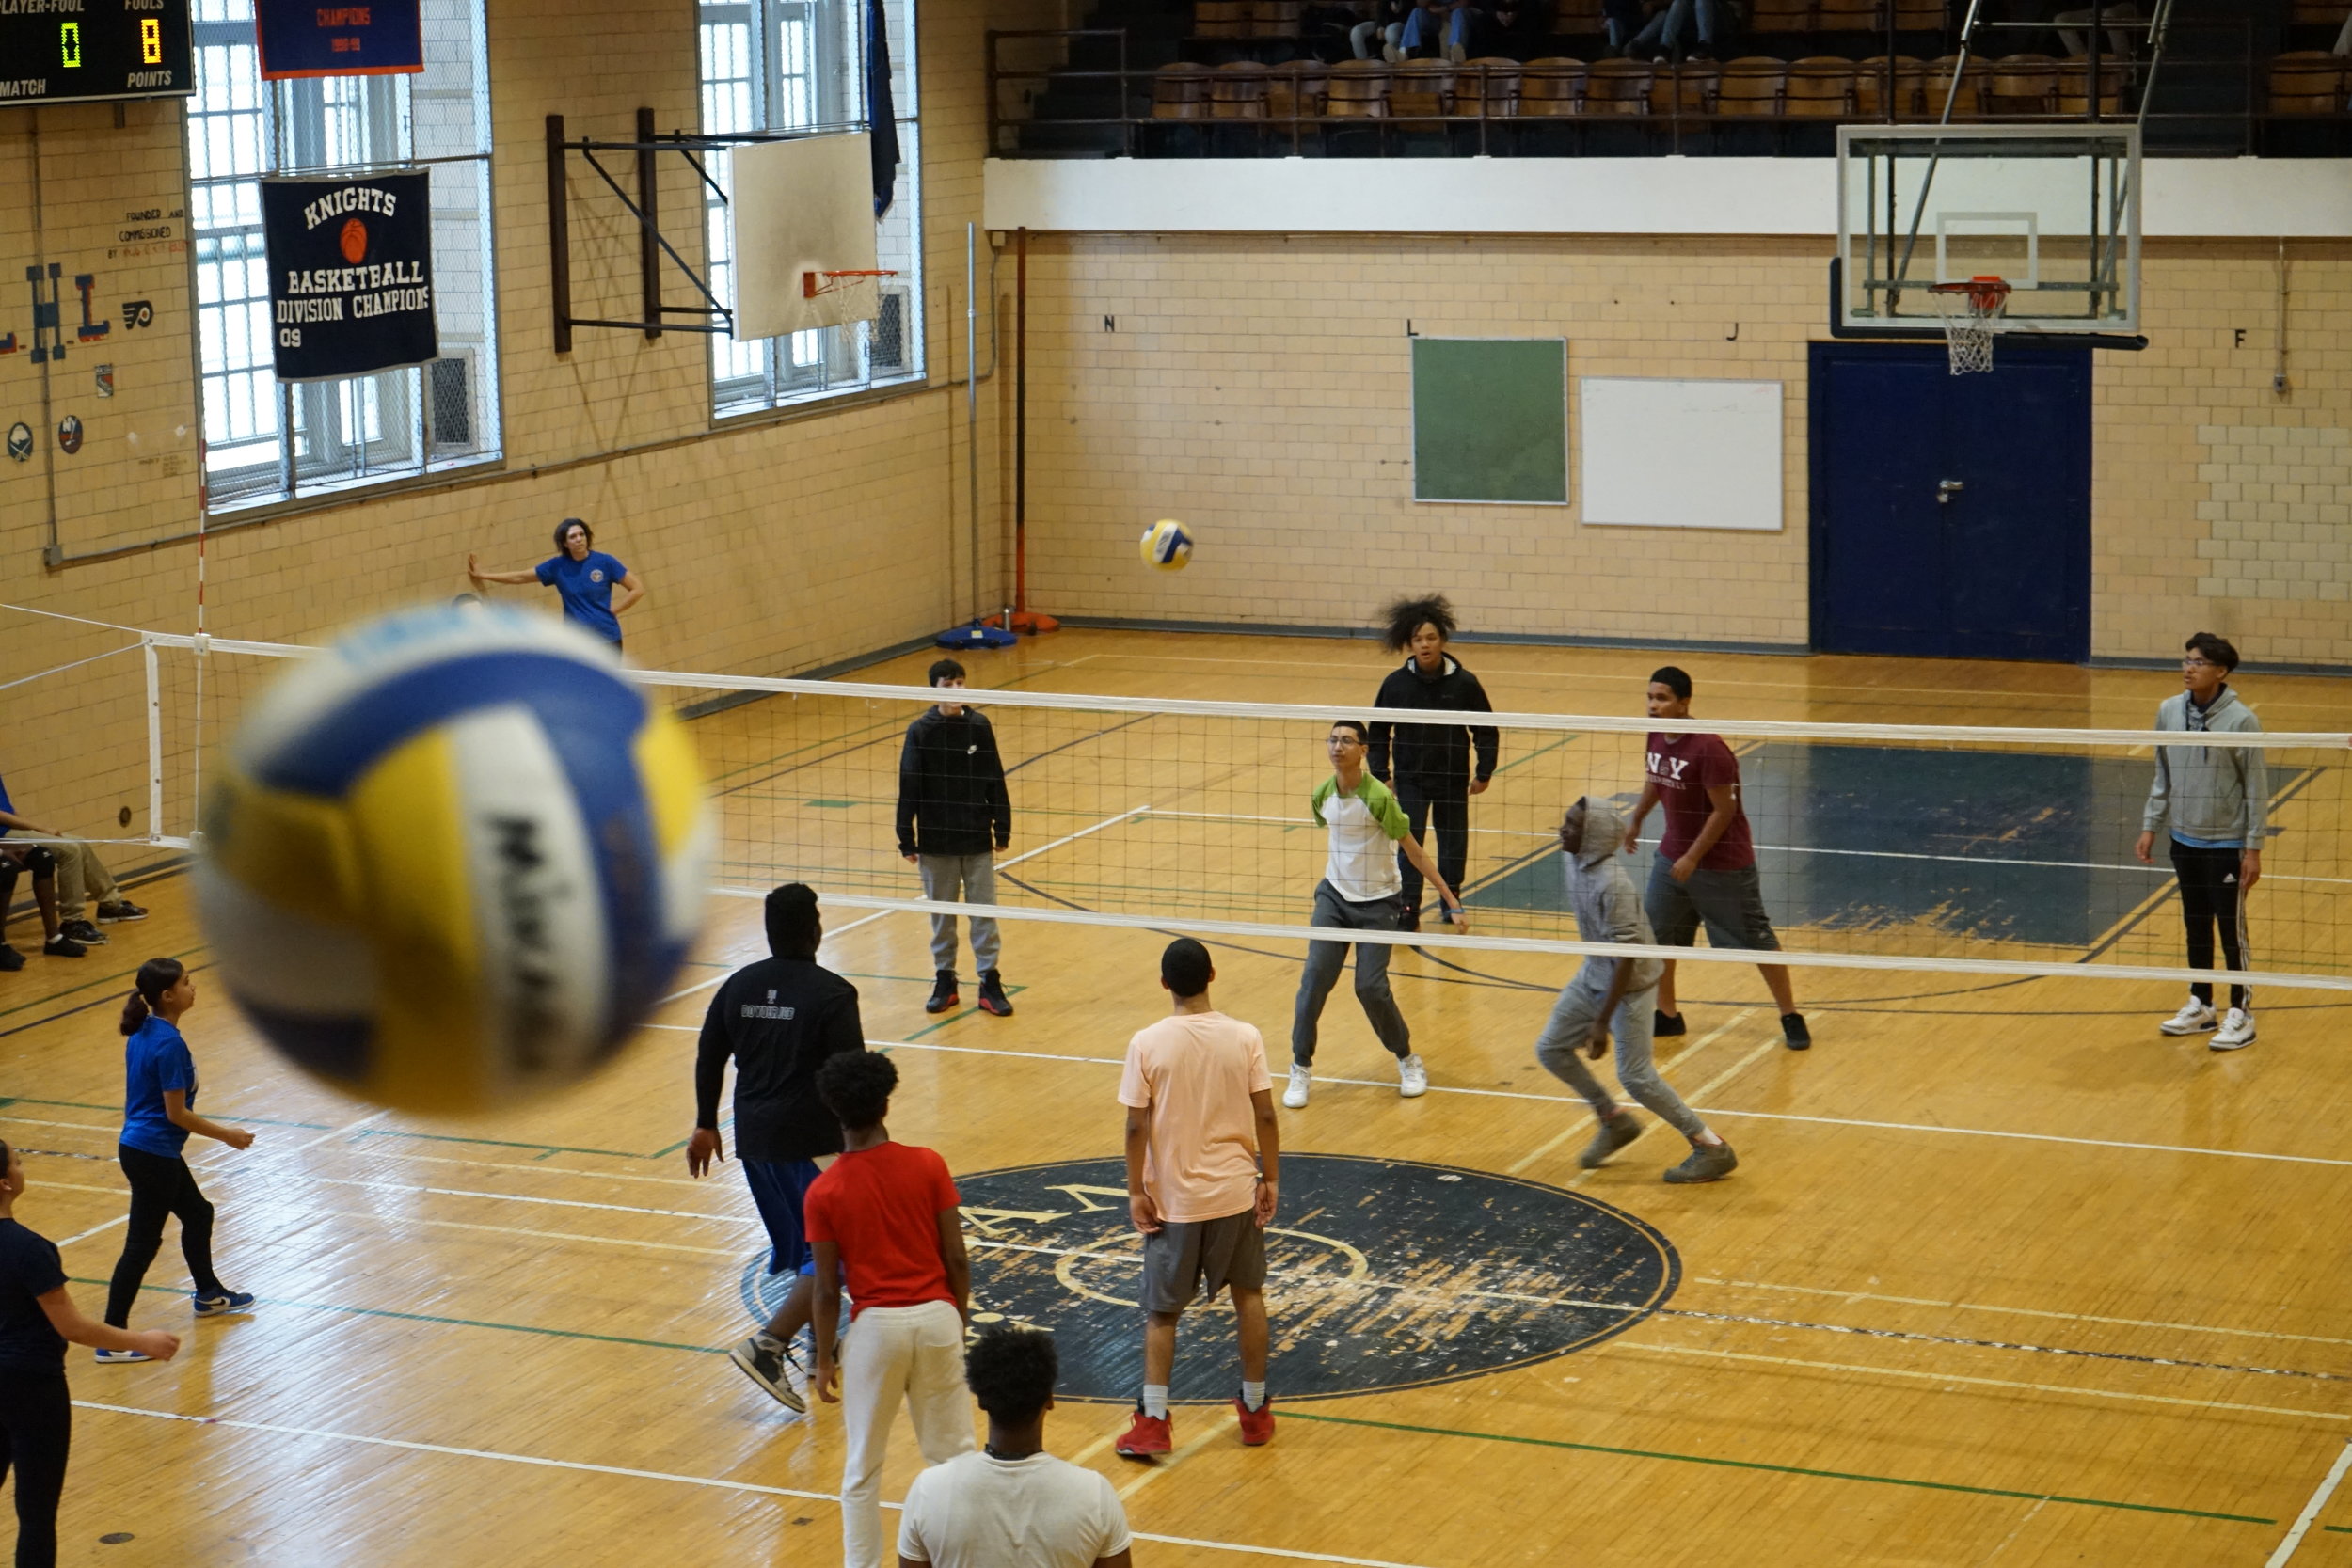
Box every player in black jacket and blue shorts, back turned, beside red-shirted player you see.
[687,881,866,1411]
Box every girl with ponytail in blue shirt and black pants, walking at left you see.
[99,959,254,1361]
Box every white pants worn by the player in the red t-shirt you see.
[842,1303,972,1568]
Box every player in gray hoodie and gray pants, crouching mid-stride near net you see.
[1536,795,1740,1182]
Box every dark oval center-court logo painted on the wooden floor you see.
[743,1154,1682,1403]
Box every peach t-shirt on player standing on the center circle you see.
[1120,1013,1275,1225]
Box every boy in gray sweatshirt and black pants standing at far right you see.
[2136,632,2270,1051]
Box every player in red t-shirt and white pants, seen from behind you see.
[803,1051,972,1568]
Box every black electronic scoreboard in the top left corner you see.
[0,0,196,105]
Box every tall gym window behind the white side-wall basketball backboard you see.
[699,0,922,414]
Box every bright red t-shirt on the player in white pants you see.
[800,1143,962,1319]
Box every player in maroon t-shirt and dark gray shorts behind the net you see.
[1626,665,1814,1051]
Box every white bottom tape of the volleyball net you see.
[739,893,2352,994]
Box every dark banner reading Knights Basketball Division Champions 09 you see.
[262,174,440,381]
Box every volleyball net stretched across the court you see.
[78,632,2352,990]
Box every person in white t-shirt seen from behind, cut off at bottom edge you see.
[898,1323,1132,1568]
